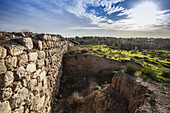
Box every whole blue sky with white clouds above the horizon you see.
[0,0,170,38]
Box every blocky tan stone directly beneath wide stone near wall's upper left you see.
[5,56,18,70]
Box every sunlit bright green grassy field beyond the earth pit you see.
[72,45,170,87]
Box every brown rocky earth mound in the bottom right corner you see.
[111,71,169,113]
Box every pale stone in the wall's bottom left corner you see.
[0,101,11,113]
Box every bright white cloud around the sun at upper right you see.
[67,0,170,30]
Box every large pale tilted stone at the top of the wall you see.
[18,38,33,49]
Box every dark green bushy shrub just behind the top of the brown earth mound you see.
[123,64,140,75]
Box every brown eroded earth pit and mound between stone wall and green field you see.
[52,55,169,113]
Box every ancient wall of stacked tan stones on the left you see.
[0,34,71,113]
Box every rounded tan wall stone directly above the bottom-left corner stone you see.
[2,88,12,100]
